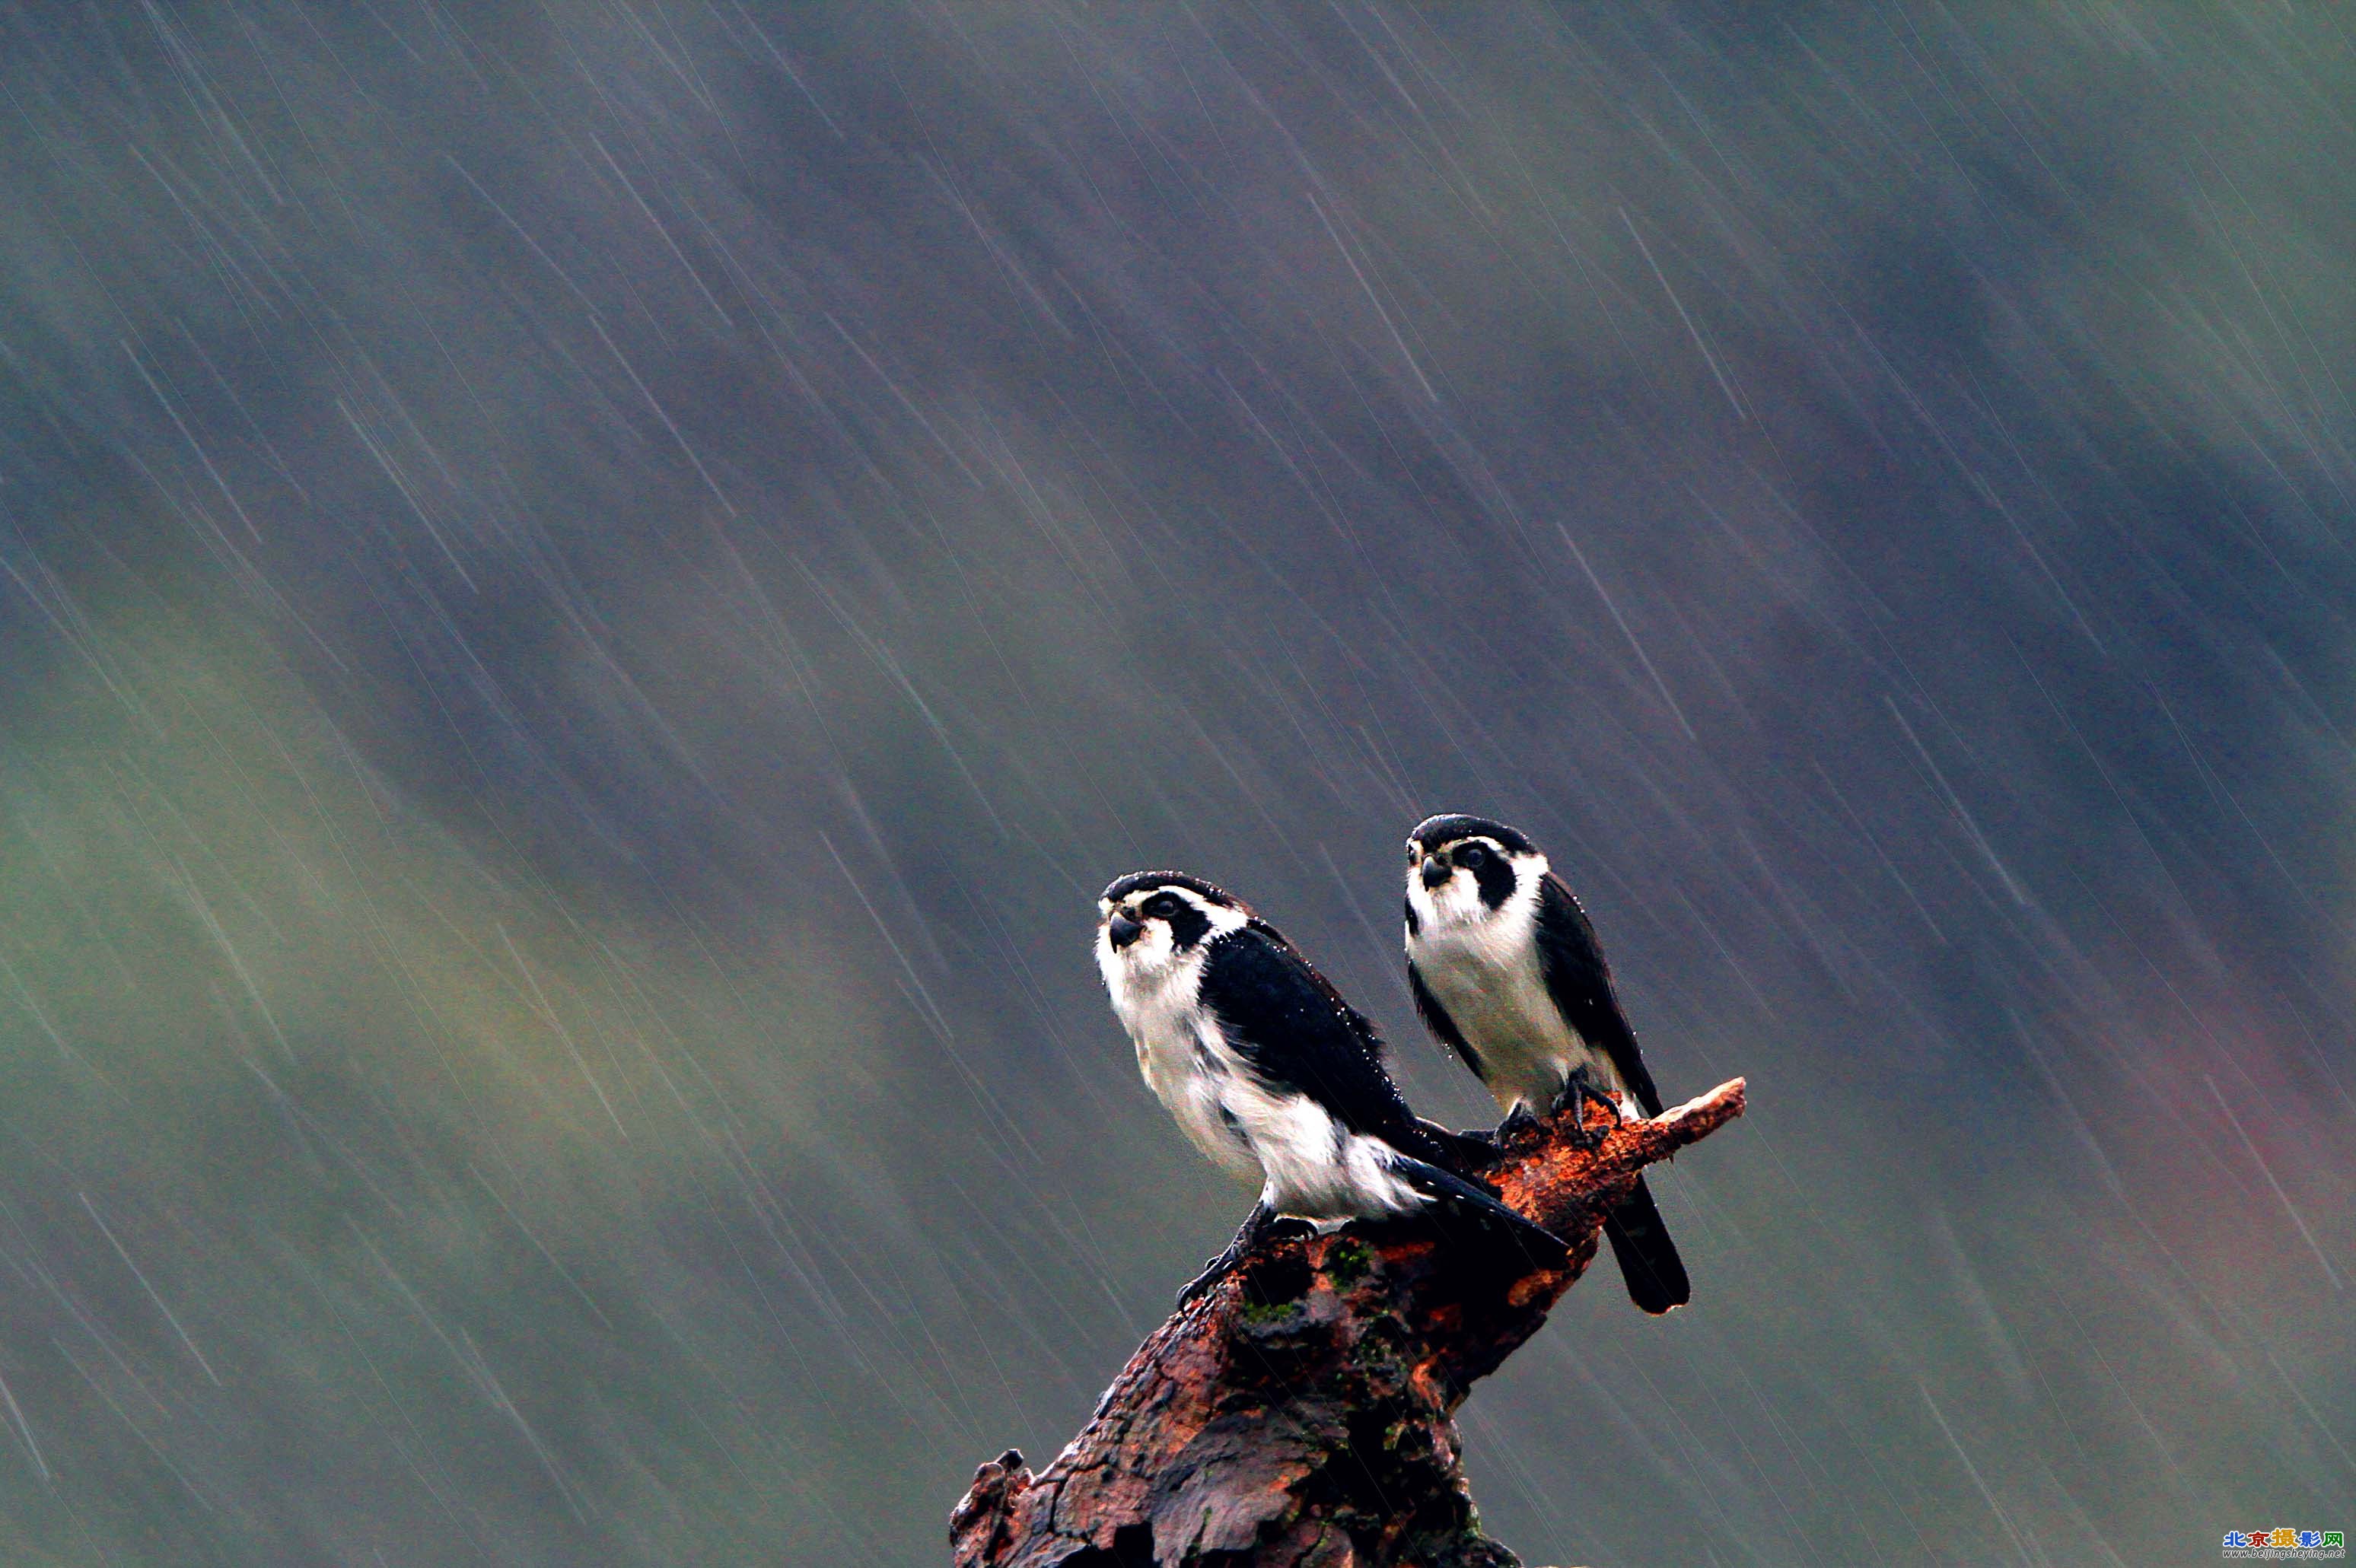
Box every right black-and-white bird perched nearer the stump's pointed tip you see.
[1406,815,1692,1314]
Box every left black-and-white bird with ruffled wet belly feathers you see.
[1096,871,1565,1302]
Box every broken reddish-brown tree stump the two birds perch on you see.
[950,1078,1743,1568]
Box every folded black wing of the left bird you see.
[1202,921,1423,1153]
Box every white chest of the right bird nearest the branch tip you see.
[1406,906,1621,1114]
